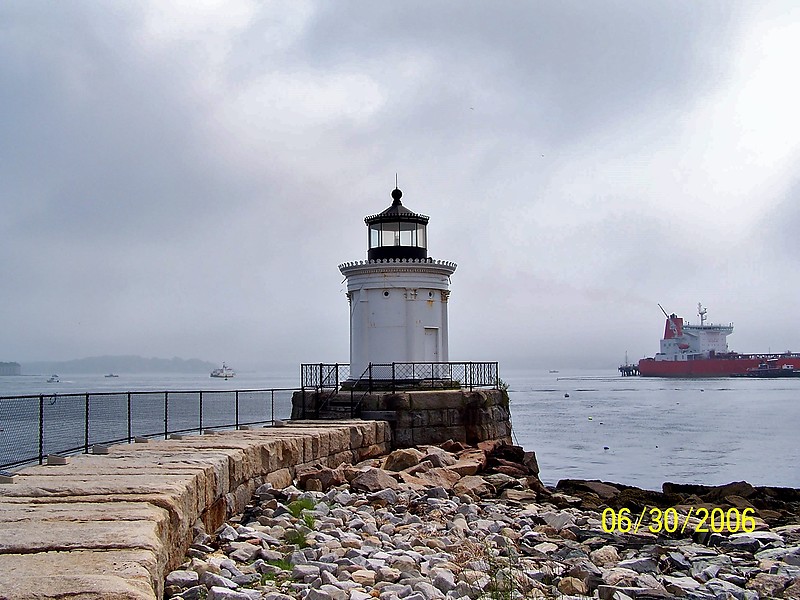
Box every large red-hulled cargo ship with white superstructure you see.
[638,304,800,377]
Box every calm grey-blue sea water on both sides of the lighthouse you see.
[0,369,800,489]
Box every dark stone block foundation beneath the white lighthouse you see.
[292,389,511,448]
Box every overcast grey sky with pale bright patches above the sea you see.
[0,0,800,369]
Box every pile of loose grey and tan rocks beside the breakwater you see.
[165,443,800,600]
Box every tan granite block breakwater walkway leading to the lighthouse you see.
[0,421,391,600]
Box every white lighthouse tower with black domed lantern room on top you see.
[339,188,456,380]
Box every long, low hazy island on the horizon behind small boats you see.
[22,356,218,375]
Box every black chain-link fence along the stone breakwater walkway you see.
[0,388,297,469]
